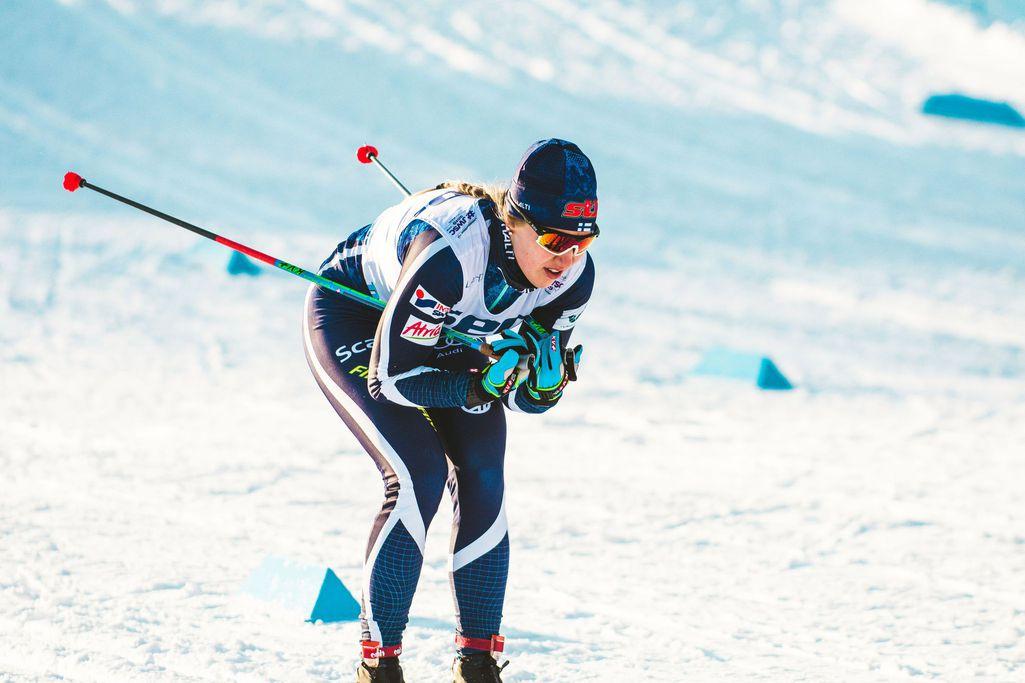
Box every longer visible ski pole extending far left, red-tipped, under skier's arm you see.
[64,171,495,358]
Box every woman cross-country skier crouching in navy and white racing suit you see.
[303,138,599,683]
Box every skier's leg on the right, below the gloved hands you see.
[431,404,509,654]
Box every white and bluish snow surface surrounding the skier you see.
[0,0,1025,682]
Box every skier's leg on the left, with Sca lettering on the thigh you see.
[303,286,448,648]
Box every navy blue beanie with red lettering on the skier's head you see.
[509,137,598,231]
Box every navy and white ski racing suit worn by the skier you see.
[303,184,595,654]
